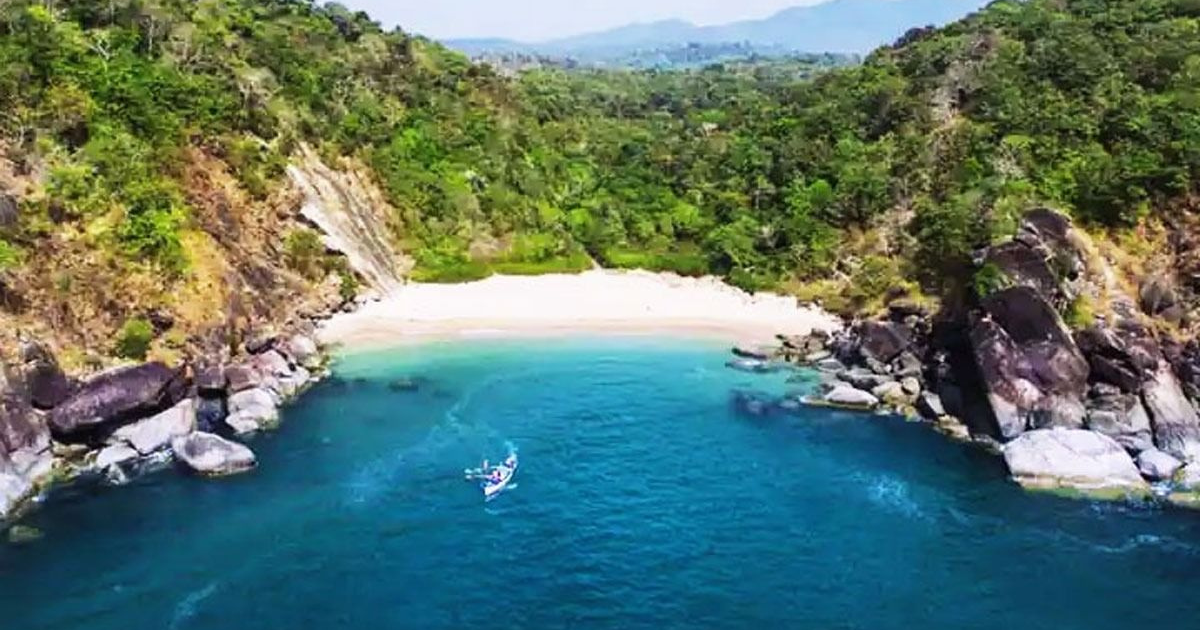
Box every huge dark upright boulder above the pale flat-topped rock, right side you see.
[970,287,1088,439]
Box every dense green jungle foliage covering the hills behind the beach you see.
[0,0,1200,305]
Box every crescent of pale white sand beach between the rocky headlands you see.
[320,270,840,348]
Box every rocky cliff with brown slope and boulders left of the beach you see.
[0,150,407,521]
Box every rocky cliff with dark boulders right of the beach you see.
[785,209,1200,503]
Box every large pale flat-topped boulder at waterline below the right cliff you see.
[1003,428,1150,493]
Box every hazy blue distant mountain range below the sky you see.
[445,0,990,65]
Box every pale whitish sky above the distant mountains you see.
[342,0,820,41]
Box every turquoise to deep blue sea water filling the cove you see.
[0,340,1200,630]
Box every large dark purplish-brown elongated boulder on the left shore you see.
[49,362,187,440]
